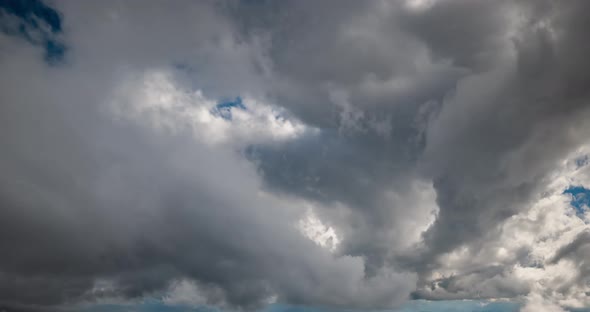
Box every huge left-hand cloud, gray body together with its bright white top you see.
[0,0,415,307]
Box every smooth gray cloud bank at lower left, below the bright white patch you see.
[0,56,411,307]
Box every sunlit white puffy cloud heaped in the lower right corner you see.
[416,151,589,308]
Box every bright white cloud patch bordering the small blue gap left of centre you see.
[110,70,310,147]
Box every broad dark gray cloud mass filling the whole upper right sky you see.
[229,1,589,304]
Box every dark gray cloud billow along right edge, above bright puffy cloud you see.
[418,3,588,266]
